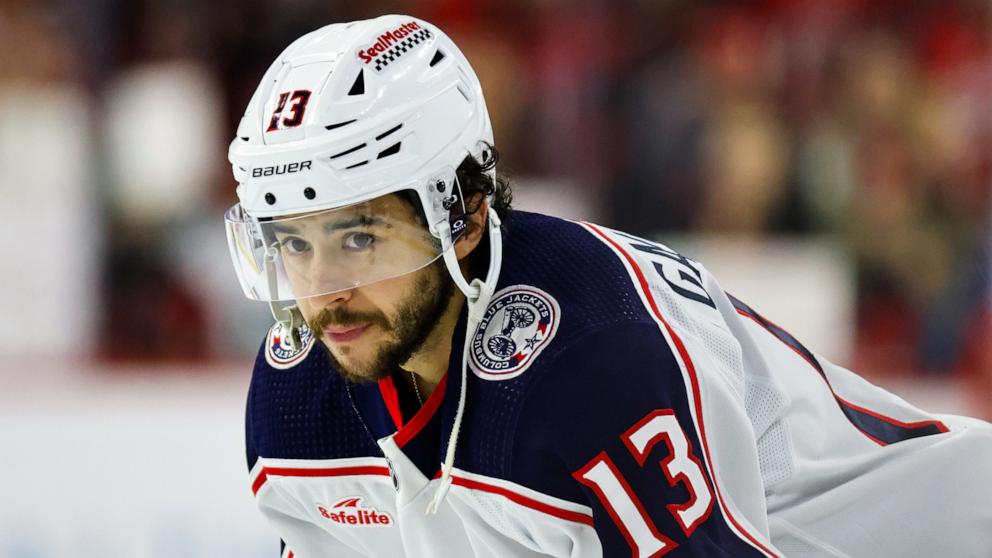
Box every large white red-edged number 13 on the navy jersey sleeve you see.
[572,409,713,558]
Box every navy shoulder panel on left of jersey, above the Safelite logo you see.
[245,331,380,468]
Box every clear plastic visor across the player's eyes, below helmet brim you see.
[224,195,450,301]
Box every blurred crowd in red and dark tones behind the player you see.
[0,0,992,417]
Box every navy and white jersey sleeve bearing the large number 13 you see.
[513,323,779,557]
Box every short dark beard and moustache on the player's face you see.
[307,260,454,383]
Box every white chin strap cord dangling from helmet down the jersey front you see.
[427,207,503,515]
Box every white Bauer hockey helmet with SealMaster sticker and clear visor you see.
[225,15,499,310]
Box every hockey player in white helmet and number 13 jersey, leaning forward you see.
[226,16,992,558]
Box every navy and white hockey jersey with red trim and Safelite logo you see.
[246,212,992,558]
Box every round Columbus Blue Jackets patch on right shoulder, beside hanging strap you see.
[470,285,561,380]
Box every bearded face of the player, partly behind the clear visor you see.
[276,196,454,382]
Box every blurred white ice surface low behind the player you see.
[0,362,966,558]
